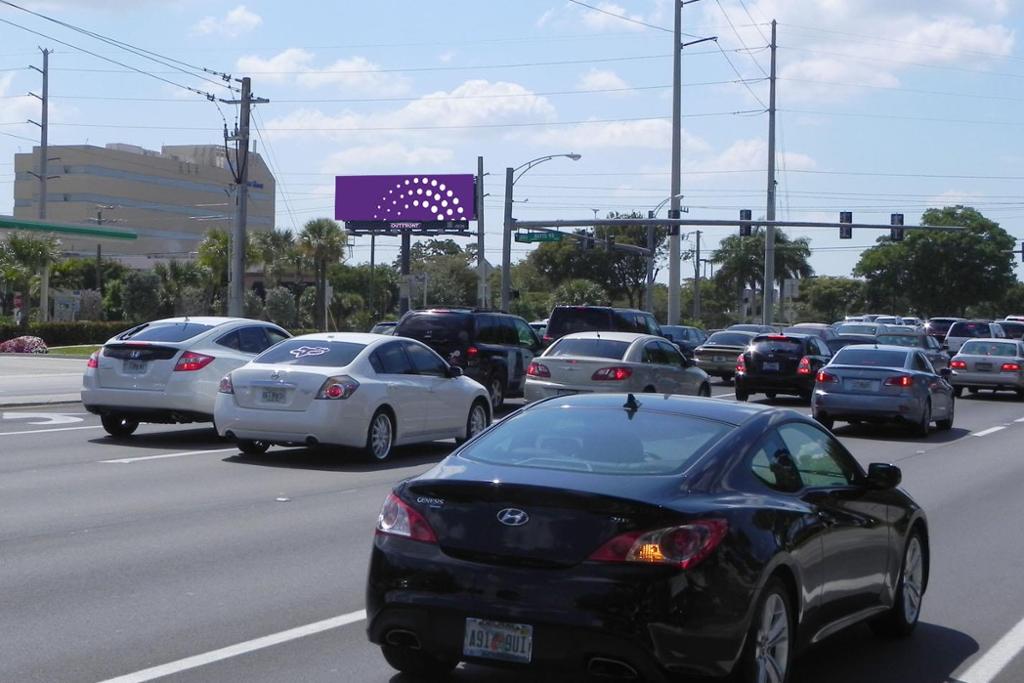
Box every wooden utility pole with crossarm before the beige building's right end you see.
[220,76,268,317]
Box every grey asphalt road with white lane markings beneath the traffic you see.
[6,386,1024,683]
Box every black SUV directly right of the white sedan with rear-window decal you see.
[394,308,541,410]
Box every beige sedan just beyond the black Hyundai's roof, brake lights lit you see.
[525,332,711,401]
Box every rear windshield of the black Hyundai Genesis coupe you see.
[460,401,732,475]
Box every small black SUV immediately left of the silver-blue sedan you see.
[736,334,831,400]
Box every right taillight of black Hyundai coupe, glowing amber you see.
[590,519,728,569]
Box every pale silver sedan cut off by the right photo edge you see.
[949,339,1024,398]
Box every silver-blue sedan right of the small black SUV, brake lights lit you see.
[811,345,954,436]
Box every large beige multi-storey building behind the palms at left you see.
[12,144,274,261]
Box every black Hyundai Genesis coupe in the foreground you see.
[367,394,929,683]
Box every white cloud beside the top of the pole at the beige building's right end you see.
[237,47,409,96]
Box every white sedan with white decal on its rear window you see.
[214,333,490,461]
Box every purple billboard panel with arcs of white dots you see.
[334,173,476,222]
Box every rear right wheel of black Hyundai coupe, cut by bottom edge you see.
[736,579,797,683]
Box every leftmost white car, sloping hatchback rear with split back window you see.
[82,316,291,436]
